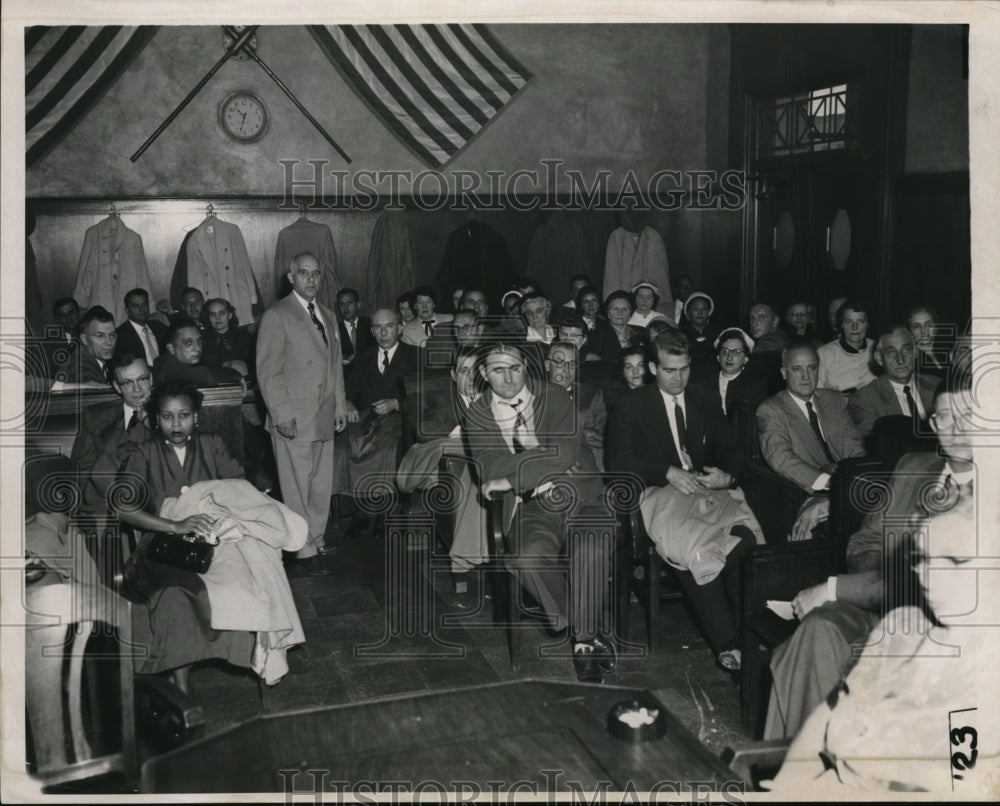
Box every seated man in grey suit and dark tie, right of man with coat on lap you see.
[757,345,865,493]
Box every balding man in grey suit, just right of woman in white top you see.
[847,325,936,437]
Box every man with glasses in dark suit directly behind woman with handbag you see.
[70,354,153,513]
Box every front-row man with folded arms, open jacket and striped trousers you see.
[466,343,617,682]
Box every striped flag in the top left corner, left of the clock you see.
[24,25,157,165]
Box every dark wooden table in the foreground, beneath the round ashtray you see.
[141,679,742,798]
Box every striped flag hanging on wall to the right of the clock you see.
[308,25,531,167]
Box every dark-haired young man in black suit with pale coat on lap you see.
[607,331,753,671]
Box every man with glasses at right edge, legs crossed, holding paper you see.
[764,373,975,739]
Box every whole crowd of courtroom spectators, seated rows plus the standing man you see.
[33,254,971,796]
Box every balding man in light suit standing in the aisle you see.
[257,253,348,576]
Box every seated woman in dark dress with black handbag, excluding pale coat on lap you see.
[115,381,254,693]
